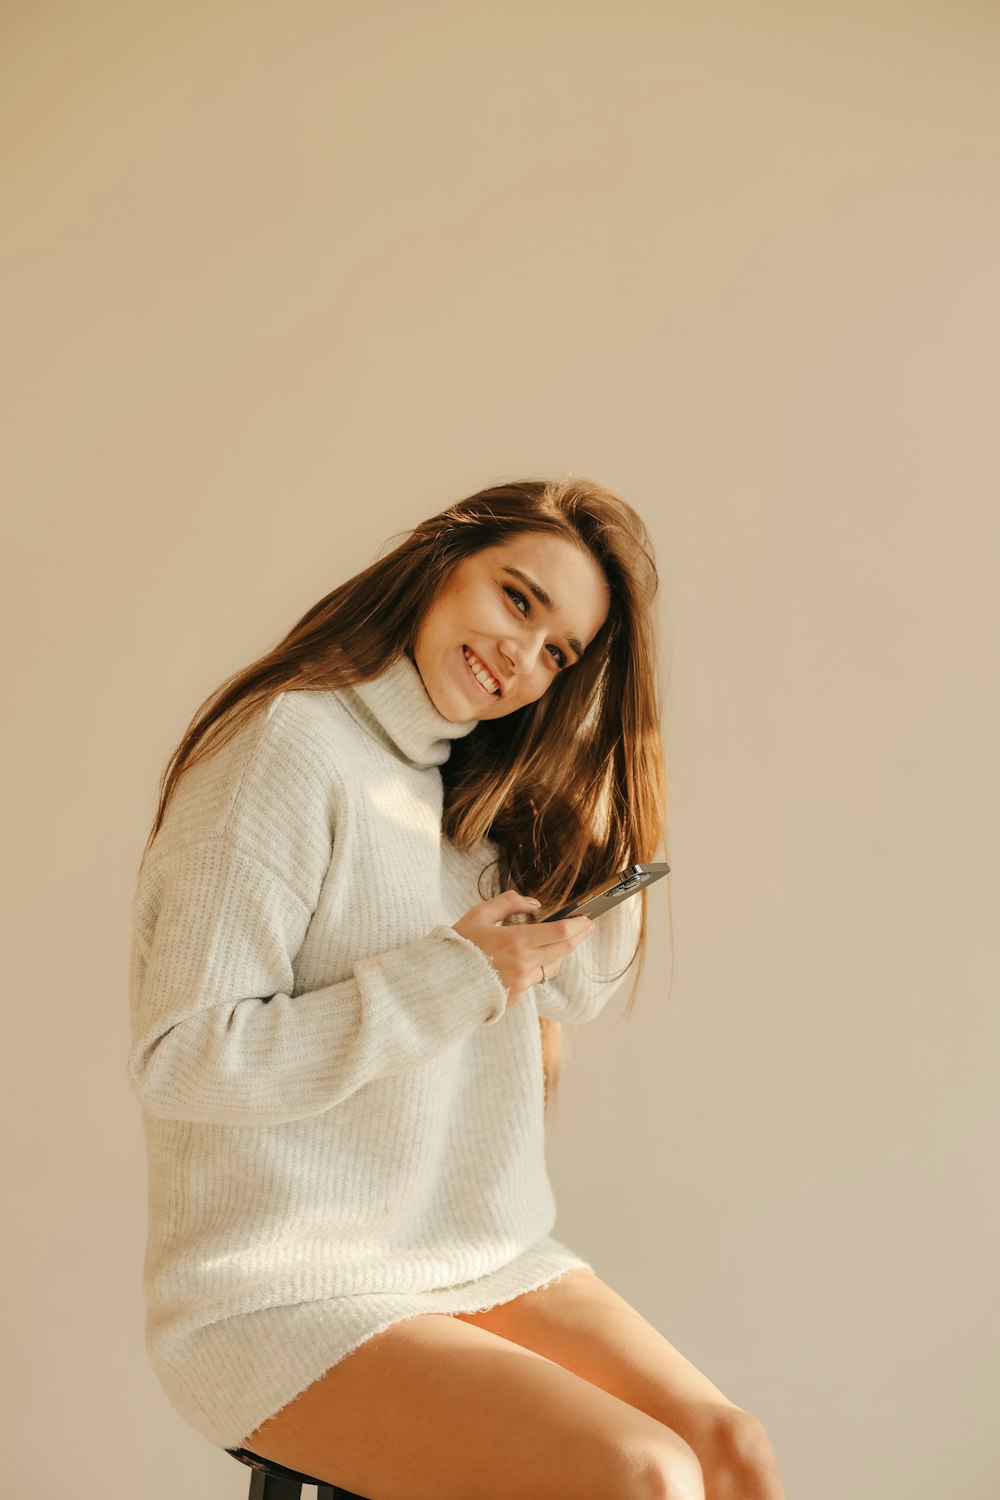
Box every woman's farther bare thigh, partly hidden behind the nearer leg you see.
[456,1268,745,1461]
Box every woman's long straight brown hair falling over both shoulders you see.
[145,477,673,1115]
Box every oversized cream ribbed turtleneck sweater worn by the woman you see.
[129,656,639,1446]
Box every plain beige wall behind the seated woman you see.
[0,0,1000,1500]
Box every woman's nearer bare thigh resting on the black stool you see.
[244,1313,703,1500]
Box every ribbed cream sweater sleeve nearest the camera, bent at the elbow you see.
[129,837,507,1125]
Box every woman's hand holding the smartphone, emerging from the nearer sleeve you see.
[453,891,594,1005]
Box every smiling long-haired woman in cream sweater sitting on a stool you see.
[130,480,781,1500]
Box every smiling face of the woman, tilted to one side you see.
[414,533,610,723]
